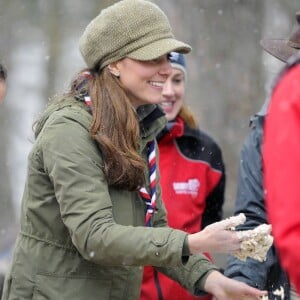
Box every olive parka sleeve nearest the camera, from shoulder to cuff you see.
[43,112,186,266]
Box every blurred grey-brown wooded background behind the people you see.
[0,0,300,264]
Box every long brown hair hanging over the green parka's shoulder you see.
[71,68,145,190]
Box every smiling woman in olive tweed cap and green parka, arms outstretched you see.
[2,0,265,300]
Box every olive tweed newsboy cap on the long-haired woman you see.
[79,0,191,69]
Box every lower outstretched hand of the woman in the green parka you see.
[204,271,267,300]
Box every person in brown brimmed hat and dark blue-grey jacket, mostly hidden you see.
[225,12,300,300]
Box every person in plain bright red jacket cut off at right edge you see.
[263,54,300,293]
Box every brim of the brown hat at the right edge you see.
[260,39,300,62]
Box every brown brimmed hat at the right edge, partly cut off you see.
[260,11,300,62]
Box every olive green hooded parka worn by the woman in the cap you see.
[2,98,216,300]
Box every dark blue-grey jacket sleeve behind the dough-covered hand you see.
[225,117,277,289]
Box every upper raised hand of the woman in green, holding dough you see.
[188,218,241,254]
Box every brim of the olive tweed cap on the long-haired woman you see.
[126,38,192,61]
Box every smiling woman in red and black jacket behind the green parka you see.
[140,52,225,300]
